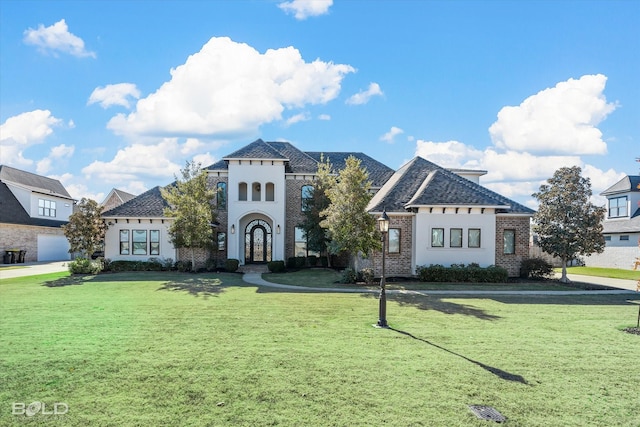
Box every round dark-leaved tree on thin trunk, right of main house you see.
[533,166,606,283]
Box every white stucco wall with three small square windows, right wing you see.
[413,207,496,269]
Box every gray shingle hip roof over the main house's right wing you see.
[369,157,534,215]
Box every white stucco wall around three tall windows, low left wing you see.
[104,218,177,261]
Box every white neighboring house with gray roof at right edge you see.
[584,175,640,270]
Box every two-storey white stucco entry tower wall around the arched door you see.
[227,160,286,264]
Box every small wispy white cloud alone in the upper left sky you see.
[24,19,96,58]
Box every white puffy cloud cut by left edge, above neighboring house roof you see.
[0,110,62,166]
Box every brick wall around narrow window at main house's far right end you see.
[496,216,530,277]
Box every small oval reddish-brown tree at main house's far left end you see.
[62,197,107,258]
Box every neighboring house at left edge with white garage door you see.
[0,165,75,262]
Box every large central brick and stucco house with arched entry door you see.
[104,140,534,276]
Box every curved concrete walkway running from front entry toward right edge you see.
[242,273,638,296]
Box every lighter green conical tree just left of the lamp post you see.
[320,156,381,270]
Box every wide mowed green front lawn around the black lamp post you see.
[0,273,640,427]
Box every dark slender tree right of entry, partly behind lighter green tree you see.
[300,156,336,265]
